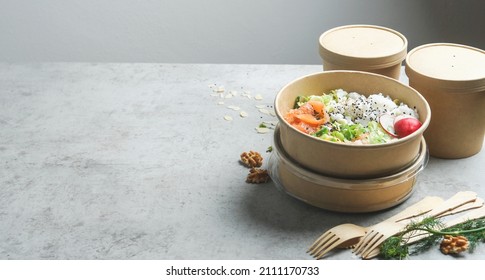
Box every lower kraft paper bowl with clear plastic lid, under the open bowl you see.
[268,124,429,213]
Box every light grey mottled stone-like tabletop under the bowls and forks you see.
[0,63,485,260]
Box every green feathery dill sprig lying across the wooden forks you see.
[380,217,485,259]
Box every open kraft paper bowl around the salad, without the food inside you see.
[275,70,431,179]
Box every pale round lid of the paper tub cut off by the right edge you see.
[406,43,485,91]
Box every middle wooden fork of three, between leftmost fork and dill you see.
[353,191,477,259]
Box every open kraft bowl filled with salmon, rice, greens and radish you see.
[275,70,431,179]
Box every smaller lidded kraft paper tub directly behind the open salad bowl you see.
[319,25,408,79]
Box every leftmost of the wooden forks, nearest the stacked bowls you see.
[307,196,443,259]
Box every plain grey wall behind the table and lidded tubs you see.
[0,0,485,64]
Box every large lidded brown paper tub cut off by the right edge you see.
[405,43,485,159]
